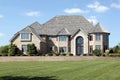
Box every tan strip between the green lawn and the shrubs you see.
[0,56,120,62]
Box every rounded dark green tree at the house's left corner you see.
[8,44,19,56]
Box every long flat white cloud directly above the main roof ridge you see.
[64,8,89,14]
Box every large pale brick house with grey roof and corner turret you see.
[10,15,110,55]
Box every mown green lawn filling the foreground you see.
[0,60,120,80]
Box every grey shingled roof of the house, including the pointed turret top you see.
[11,15,109,41]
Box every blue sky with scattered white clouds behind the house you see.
[0,0,120,47]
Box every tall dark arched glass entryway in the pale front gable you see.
[76,36,84,55]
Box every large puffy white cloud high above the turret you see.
[87,2,109,13]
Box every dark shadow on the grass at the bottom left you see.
[0,76,57,80]
